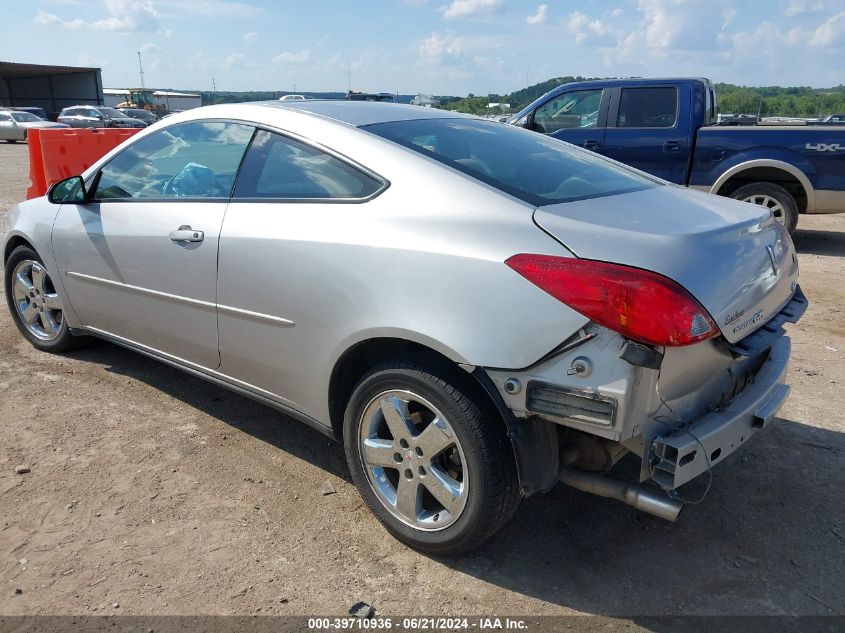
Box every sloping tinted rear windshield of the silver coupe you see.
[363,119,658,206]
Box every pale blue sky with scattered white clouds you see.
[6,0,845,95]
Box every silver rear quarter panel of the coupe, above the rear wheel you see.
[218,111,587,420]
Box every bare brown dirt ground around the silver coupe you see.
[0,145,845,619]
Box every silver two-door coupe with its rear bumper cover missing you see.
[3,100,807,554]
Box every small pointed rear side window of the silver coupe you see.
[234,130,383,200]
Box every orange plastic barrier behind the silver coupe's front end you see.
[26,128,140,199]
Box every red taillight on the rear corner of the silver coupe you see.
[505,254,719,347]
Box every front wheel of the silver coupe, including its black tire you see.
[4,246,90,353]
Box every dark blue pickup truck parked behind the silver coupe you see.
[511,78,845,232]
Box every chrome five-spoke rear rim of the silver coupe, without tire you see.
[358,390,470,532]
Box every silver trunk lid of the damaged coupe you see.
[534,186,798,343]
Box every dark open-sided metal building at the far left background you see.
[0,61,103,113]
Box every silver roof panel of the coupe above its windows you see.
[256,99,467,127]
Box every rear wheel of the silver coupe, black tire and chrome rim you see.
[343,356,519,555]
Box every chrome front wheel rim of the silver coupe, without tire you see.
[12,259,63,341]
